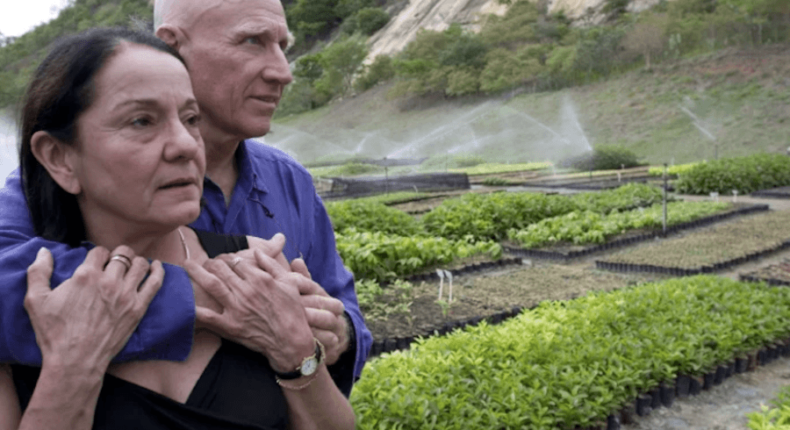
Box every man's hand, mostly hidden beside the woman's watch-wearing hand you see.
[291,258,349,365]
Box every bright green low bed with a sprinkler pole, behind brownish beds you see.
[507,202,730,248]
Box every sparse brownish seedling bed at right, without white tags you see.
[596,211,790,275]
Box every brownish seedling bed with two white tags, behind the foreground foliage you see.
[362,264,663,353]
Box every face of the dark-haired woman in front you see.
[67,42,206,230]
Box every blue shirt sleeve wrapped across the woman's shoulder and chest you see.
[0,169,195,366]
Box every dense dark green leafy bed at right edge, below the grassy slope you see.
[675,154,790,194]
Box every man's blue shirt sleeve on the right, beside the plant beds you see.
[305,194,373,386]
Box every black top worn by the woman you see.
[11,231,288,430]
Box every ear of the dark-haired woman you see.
[30,131,82,195]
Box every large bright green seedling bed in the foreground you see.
[351,276,790,430]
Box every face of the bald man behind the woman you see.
[180,0,293,141]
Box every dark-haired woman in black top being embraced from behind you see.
[0,29,354,430]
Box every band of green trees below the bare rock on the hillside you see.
[278,0,790,116]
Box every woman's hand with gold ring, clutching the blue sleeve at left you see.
[25,246,164,374]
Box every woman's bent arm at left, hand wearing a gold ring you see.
[0,247,164,430]
